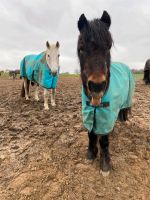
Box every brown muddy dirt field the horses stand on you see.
[0,77,150,200]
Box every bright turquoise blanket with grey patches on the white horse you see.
[20,52,59,89]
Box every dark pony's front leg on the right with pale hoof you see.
[99,135,111,176]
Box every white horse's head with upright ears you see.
[46,41,60,76]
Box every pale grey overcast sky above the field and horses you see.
[0,0,150,73]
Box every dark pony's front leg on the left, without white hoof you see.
[87,131,98,160]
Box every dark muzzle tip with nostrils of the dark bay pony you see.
[88,81,106,92]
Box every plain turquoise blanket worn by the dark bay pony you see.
[82,63,135,135]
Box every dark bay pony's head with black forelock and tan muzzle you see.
[77,11,113,106]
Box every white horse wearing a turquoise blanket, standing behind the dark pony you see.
[20,41,60,110]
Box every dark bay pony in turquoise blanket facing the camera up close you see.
[77,11,135,175]
